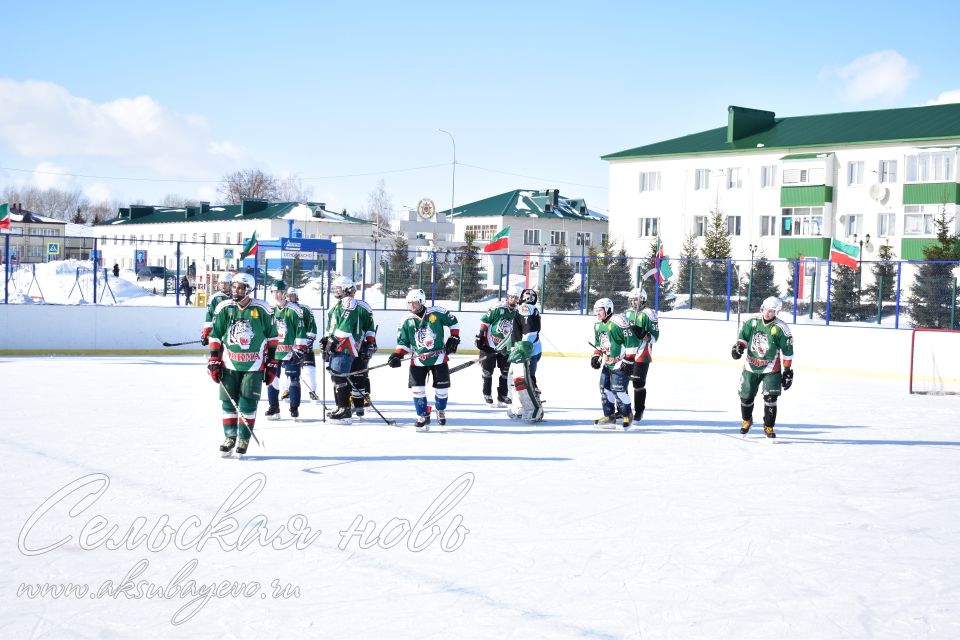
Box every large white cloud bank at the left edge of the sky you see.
[0,78,244,177]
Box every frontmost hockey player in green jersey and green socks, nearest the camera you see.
[207,273,280,456]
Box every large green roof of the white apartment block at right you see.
[601,104,960,160]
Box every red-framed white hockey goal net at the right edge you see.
[910,329,960,395]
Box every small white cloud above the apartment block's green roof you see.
[820,50,917,103]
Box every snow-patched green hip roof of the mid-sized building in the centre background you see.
[441,189,607,220]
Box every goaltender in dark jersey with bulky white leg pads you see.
[507,289,543,422]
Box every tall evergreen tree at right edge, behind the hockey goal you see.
[907,209,960,329]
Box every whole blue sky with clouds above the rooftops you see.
[0,0,960,211]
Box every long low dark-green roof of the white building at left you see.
[94,200,370,227]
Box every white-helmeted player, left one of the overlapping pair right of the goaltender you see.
[590,298,636,430]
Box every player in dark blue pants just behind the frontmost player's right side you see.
[265,280,307,420]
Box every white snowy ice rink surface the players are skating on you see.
[0,352,960,638]
